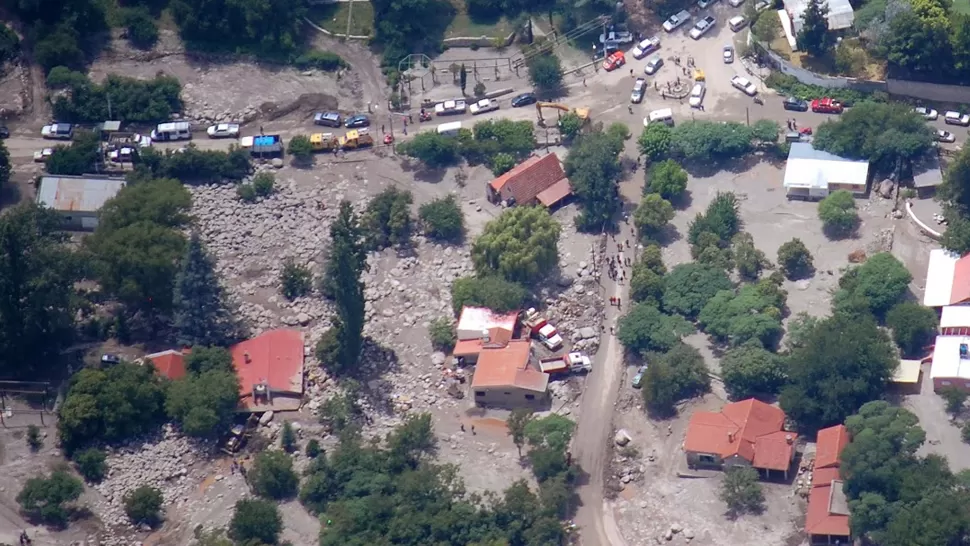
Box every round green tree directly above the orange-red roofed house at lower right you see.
[721,341,788,400]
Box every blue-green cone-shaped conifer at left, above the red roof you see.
[172,233,235,346]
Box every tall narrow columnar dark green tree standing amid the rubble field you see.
[317,201,368,373]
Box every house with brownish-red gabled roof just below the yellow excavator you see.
[485,153,573,207]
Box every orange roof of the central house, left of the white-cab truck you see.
[472,339,549,393]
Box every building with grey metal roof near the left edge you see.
[37,175,125,231]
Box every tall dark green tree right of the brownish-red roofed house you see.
[564,132,623,232]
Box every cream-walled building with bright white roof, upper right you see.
[783,142,869,199]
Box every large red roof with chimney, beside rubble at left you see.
[229,329,303,408]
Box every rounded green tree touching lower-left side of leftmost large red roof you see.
[165,370,239,438]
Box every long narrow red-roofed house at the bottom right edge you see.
[805,425,852,544]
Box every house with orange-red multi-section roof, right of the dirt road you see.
[684,398,798,479]
